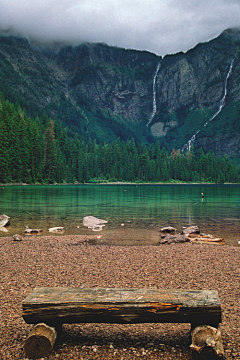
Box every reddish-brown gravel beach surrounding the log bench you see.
[0,235,240,360]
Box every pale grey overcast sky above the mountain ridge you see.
[0,0,240,55]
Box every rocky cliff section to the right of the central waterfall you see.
[152,30,240,155]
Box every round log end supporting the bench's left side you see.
[24,323,57,359]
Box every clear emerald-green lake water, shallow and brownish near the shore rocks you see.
[0,185,240,245]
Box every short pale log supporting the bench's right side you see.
[190,325,224,357]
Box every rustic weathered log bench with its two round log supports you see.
[22,287,223,359]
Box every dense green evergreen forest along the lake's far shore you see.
[0,94,240,184]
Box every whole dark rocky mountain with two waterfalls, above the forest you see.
[0,29,240,157]
